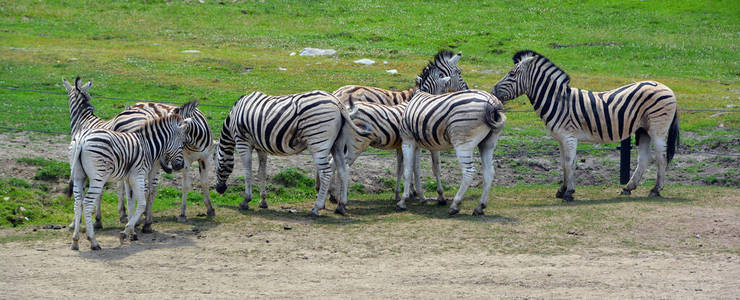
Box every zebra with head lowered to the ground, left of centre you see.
[216,91,367,216]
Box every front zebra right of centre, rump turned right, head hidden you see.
[396,90,506,215]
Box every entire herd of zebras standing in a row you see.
[63,50,679,250]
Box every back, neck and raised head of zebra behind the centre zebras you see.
[332,50,468,105]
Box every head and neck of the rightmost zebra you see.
[491,50,570,102]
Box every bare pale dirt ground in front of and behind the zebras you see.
[0,134,740,299]
